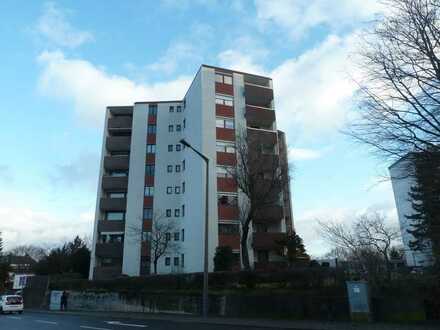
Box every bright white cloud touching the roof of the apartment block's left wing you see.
[38,51,192,126]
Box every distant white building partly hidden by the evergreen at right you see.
[389,155,433,267]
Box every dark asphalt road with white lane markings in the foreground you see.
[0,311,282,330]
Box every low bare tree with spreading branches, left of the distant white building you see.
[319,212,400,278]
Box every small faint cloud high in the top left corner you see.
[35,2,93,48]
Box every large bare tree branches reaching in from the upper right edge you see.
[346,0,440,160]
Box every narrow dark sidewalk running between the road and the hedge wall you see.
[27,309,439,330]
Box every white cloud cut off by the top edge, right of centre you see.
[255,0,383,39]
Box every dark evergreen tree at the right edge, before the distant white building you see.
[406,150,440,265]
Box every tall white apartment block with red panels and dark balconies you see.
[90,65,293,278]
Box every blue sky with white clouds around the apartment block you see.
[0,0,397,257]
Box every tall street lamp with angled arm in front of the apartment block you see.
[180,139,209,318]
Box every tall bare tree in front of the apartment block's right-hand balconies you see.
[228,132,289,270]
